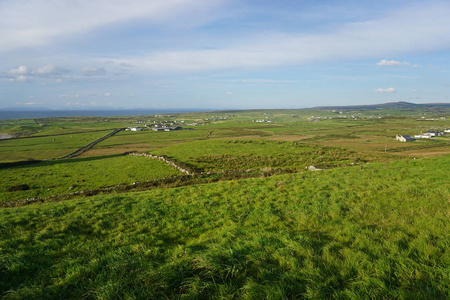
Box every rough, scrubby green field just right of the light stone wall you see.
[152,139,361,172]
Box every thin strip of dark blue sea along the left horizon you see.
[0,109,206,120]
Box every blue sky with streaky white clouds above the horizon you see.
[0,0,450,110]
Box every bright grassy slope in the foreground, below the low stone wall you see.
[0,155,450,299]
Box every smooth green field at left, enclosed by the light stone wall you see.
[0,155,181,202]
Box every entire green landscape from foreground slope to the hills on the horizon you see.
[0,106,450,299]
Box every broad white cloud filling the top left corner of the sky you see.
[0,0,223,51]
